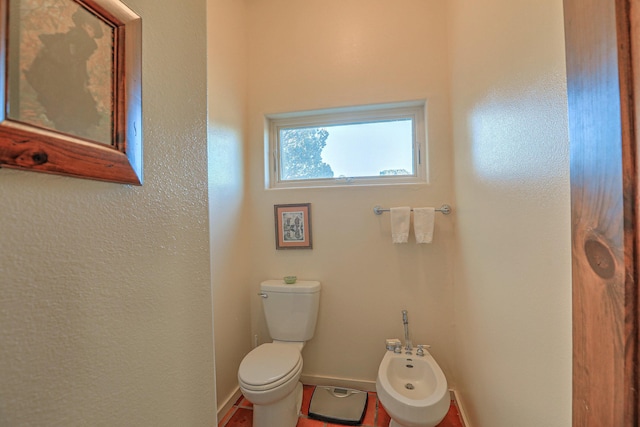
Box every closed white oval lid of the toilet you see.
[238,343,302,386]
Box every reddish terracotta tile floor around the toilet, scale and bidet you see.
[218,385,463,427]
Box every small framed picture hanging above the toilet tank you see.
[274,203,313,249]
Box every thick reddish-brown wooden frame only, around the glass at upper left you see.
[0,0,142,185]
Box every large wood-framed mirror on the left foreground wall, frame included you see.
[0,0,142,185]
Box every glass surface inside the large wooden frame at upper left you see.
[7,0,114,145]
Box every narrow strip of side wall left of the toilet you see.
[207,0,251,415]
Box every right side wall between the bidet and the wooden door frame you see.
[451,0,571,427]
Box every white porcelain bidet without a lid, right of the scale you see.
[376,350,451,427]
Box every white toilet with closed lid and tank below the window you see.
[238,280,320,427]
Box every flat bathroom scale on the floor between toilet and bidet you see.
[309,386,367,426]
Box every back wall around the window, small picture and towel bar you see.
[242,0,455,386]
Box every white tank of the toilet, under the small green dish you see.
[260,280,320,342]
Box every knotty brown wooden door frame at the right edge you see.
[564,0,640,427]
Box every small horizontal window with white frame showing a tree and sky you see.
[267,102,427,188]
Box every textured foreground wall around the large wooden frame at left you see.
[0,0,215,427]
